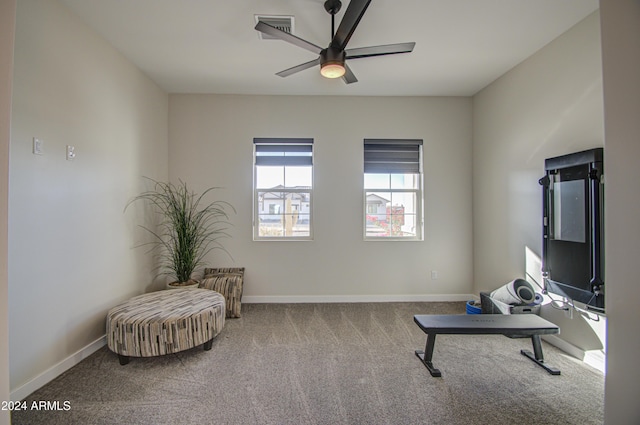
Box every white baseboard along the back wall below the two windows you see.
[242,294,474,304]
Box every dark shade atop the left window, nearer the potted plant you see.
[253,138,313,166]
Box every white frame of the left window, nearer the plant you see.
[252,138,315,241]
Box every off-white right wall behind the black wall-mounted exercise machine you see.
[473,12,607,363]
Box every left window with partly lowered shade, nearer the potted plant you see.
[253,138,313,240]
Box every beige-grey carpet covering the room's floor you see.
[12,303,604,425]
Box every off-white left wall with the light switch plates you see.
[8,0,168,398]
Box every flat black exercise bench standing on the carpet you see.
[413,314,560,377]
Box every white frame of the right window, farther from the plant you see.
[362,139,424,241]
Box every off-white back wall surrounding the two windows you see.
[169,95,472,301]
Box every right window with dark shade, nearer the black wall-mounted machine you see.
[364,139,423,240]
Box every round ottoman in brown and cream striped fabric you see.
[107,289,225,365]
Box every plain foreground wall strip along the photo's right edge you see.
[600,0,640,425]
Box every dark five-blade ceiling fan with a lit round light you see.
[255,0,416,84]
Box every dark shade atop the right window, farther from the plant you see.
[364,139,422,174]
